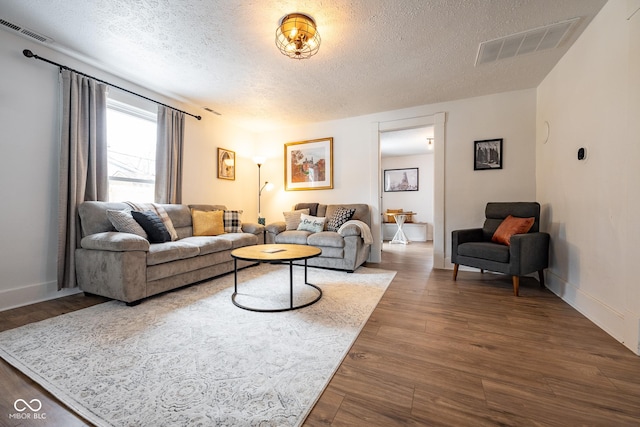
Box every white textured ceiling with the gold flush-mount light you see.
[0,0,606,131]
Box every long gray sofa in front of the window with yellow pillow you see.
[75,202,264,305]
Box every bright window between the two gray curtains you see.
[107,99,157,202]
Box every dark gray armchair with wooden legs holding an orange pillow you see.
[451,202,550,296]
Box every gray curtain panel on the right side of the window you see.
[155,105,184,203]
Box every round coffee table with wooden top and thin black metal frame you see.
[231,244,322,313]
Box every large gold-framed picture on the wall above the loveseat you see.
[284,138,333,191]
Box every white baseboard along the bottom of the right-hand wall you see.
[545,270,639,354]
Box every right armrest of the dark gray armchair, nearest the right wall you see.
[509,232,551,275]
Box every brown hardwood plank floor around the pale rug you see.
[0,243,640,426]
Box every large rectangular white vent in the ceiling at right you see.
[476,18,580,67]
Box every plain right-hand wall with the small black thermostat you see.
[536,1,640,354]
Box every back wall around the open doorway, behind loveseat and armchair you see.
[256,89,536,267]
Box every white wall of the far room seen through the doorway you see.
[381,154,434,240]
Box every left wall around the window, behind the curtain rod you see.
[0,30,257,310]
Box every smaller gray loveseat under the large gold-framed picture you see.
[266,203,371,272]
